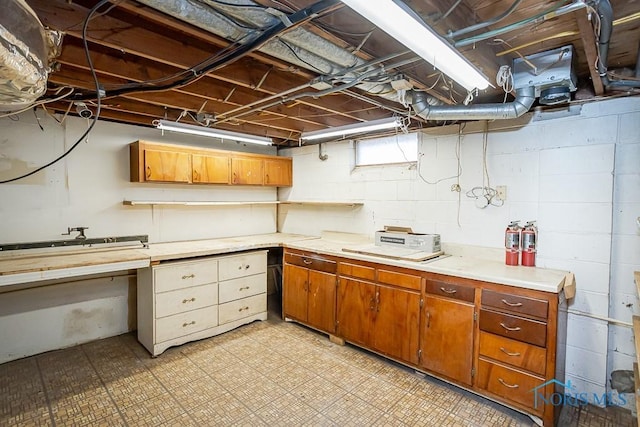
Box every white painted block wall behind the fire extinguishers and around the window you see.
[278,98,640,408]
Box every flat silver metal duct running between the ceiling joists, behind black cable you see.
[139,0,400,102]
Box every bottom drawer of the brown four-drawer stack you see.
[477,359,544,413]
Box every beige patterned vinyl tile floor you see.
[0,313,635,426]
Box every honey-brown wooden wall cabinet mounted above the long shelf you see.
[129,141,293,187]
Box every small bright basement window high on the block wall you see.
[356,133,418,166]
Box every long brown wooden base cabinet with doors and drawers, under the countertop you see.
[283,249,566,426]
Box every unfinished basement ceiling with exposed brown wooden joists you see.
[20,0,640,146]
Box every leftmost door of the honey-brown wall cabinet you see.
[144,149,191,182]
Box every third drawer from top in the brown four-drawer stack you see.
[480,332,547,375]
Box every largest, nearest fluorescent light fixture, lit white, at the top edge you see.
[342,0,489,91]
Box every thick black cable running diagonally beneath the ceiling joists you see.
[73,0,340,101]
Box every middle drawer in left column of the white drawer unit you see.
[156,283,218,318]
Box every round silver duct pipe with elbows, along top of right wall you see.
[411,86,536,120]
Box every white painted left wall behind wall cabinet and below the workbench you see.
[0,110,277,363]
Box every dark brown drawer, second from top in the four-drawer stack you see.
[480,309,547,347]
